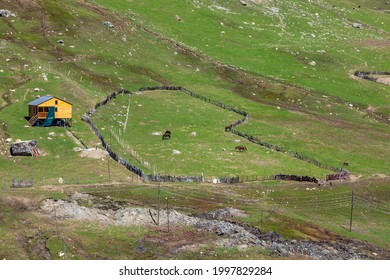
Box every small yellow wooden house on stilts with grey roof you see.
[28,95,72,126]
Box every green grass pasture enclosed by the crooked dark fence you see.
[93,91,330,178]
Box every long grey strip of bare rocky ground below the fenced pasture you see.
[41,193,390,260]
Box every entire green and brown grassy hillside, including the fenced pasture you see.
[0,0,390,259]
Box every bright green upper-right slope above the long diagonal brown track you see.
[90,0,390,111]
